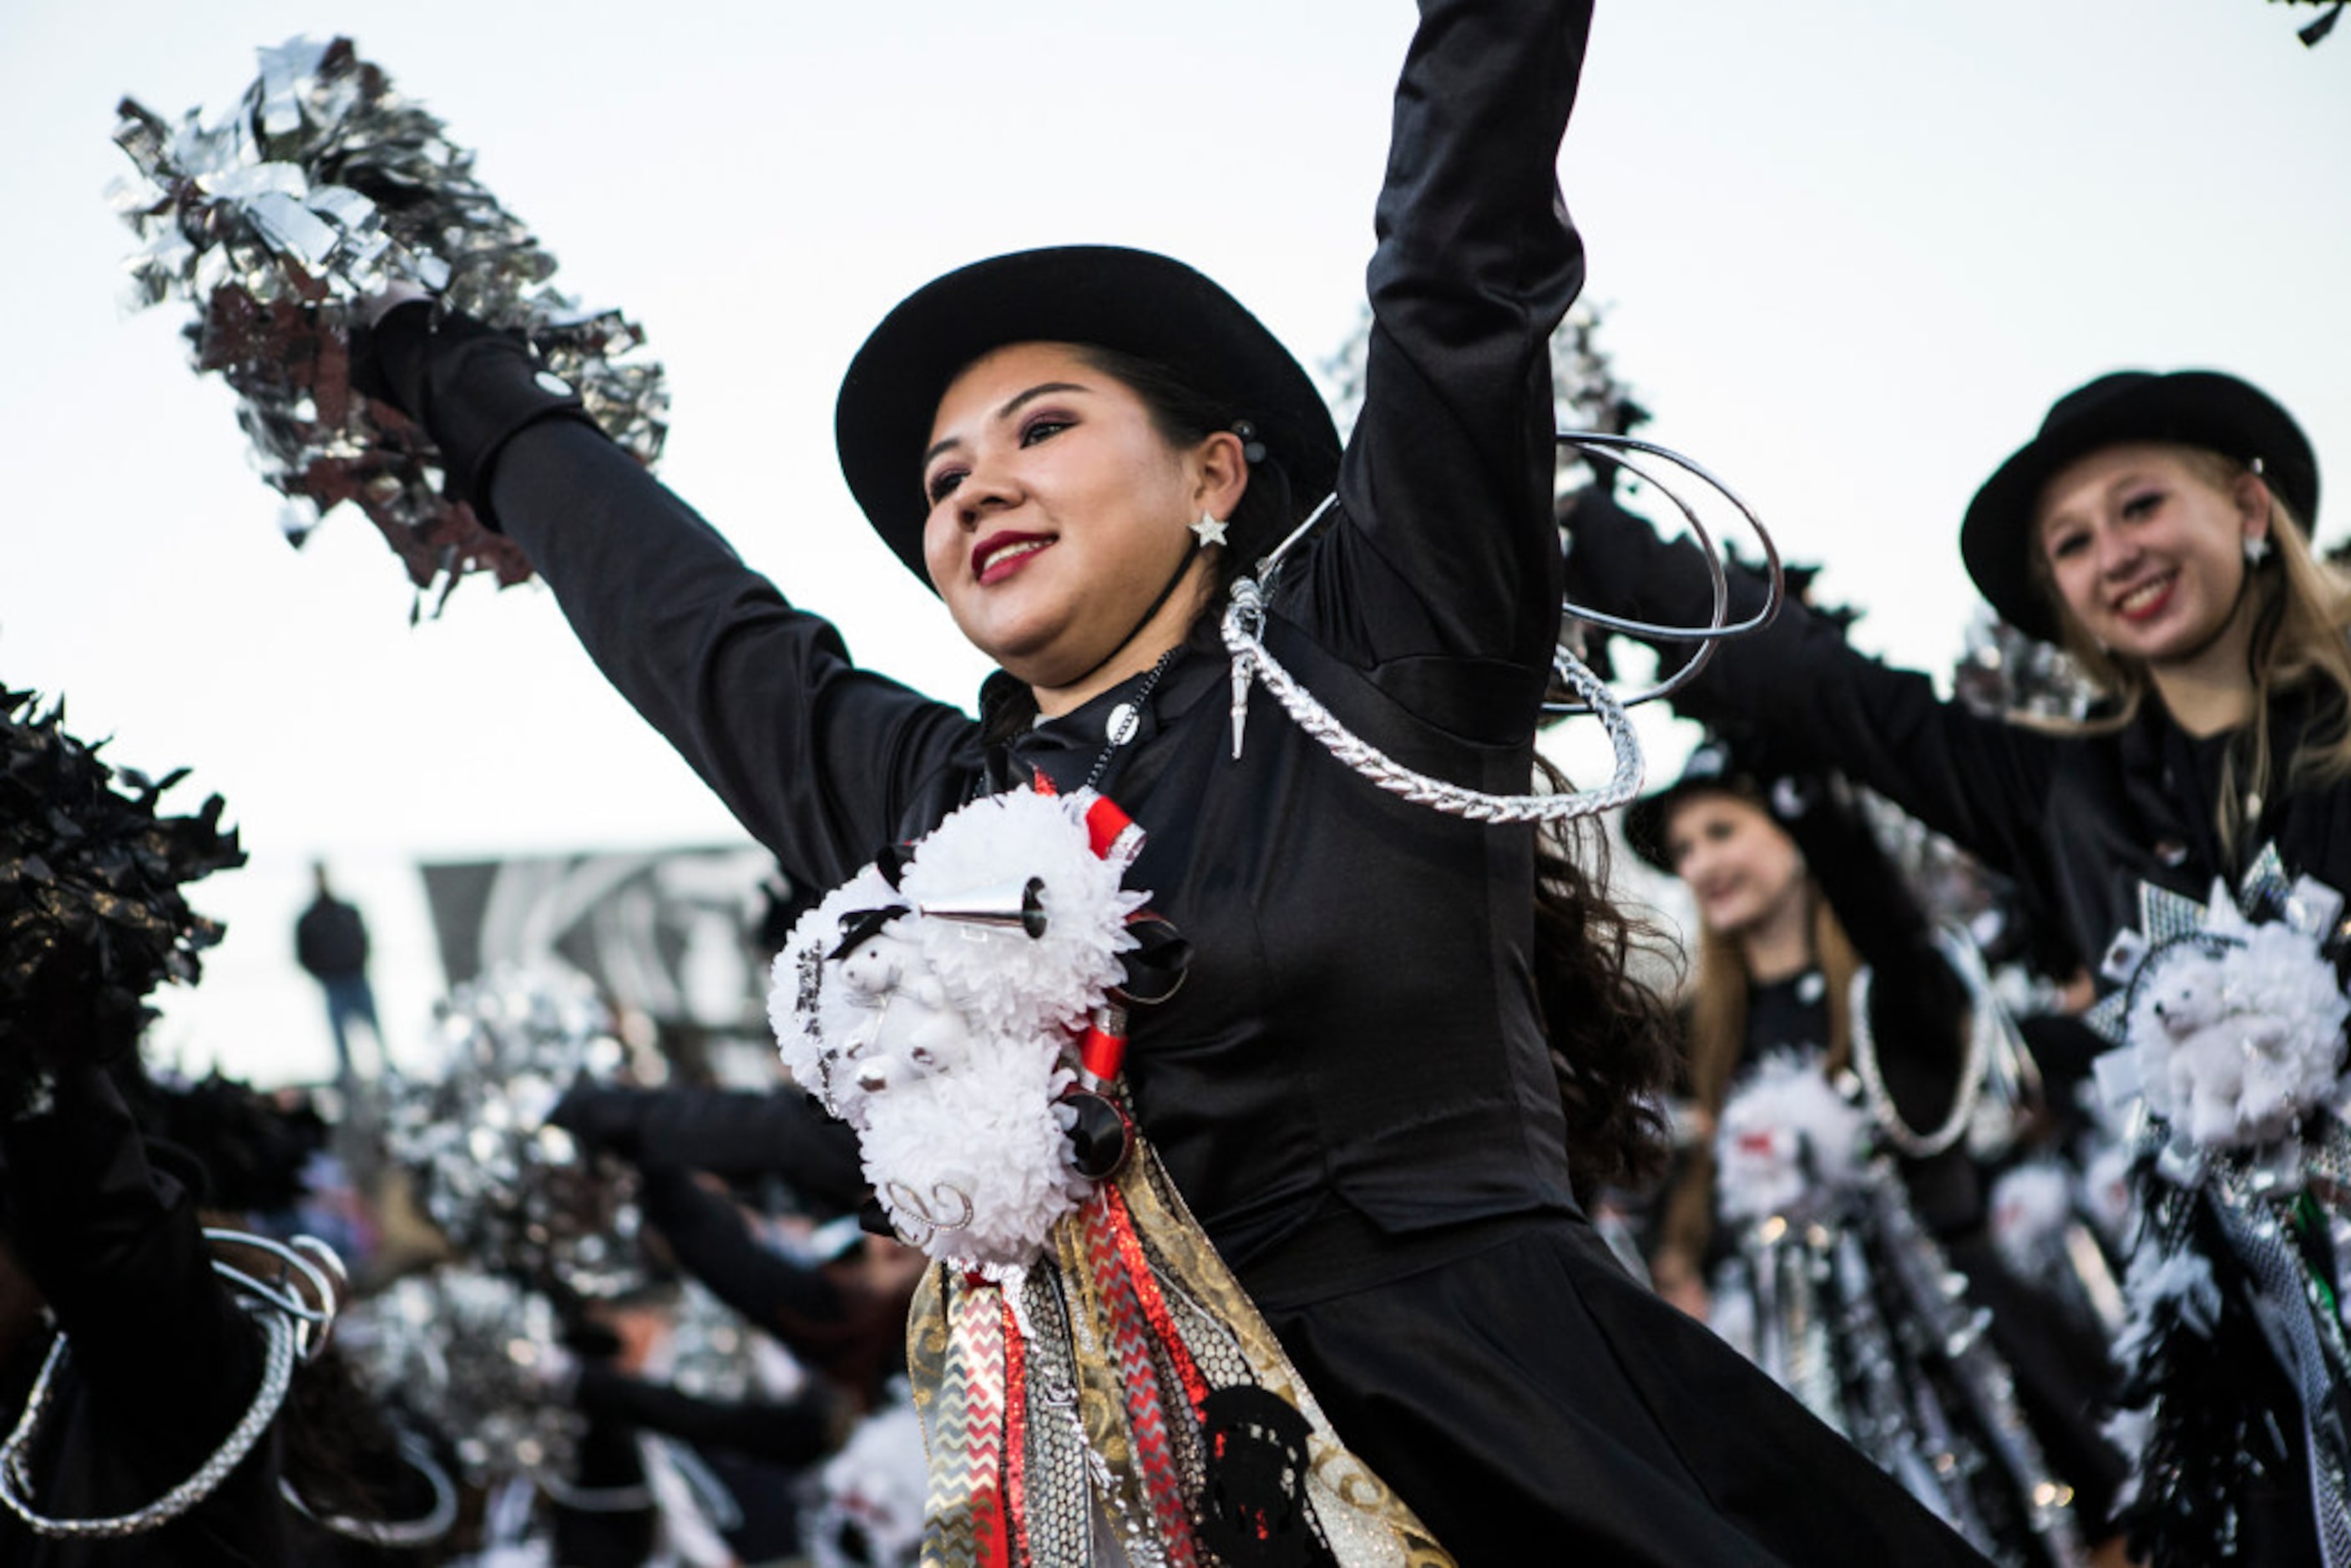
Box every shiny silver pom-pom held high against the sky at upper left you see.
[113,38,668,599]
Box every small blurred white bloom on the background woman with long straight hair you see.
[1714,1055,1869,1225]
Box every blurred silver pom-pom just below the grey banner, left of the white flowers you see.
[386,971,645,1297]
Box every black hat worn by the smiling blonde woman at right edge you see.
[1959,369,2318,642]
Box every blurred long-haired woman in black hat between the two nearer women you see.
[1625,741,2123,1563]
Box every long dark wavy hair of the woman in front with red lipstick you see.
[983,346,1676,1201]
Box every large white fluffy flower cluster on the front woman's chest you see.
[769,792,1145,1277]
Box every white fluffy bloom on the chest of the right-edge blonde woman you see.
[2127,922,2351,1150]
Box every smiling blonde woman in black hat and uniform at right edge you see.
[1570,372,2351,1565]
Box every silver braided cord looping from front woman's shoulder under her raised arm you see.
[1222,579,1641,822]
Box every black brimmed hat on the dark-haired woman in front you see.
[835,245,1340,583]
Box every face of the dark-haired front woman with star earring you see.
[922,343,1246,712]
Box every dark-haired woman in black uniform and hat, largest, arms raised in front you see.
[347,0,1973,1563]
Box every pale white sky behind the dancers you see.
[0,0,2351,1079]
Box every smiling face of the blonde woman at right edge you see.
[2038,442,2268,665]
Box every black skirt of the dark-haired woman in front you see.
[1260,1216,1984,1568]
